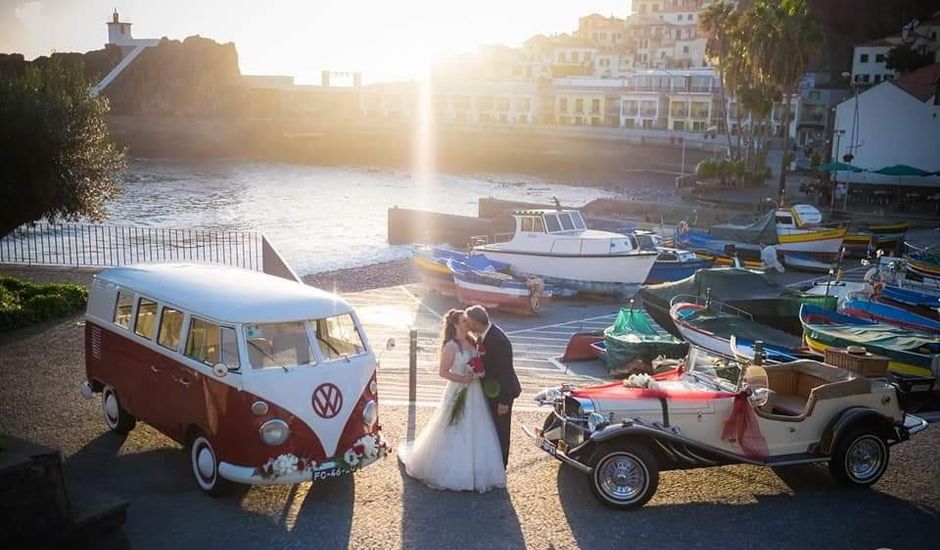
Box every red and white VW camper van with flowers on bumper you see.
[82,264,386,495]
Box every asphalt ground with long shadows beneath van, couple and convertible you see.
[0,276,940,550]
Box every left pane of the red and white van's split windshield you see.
[245,321,314,369]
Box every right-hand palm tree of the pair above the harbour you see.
[744,0,823,202]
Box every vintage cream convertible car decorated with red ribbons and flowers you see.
[523,348,927,509]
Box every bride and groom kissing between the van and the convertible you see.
[398,306,522,493]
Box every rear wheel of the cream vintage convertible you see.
[829,426,891,487]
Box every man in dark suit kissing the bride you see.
[466,306,522,466]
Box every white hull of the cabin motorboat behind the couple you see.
[481,247,656,296]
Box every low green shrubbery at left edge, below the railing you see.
[0,275,88,331]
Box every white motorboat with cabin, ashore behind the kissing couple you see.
[474,209,658,296]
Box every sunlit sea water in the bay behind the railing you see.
[106,160,612,275]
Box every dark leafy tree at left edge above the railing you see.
[0,60,125,236]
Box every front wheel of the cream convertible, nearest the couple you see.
[590,442,659,510]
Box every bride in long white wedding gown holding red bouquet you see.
[398,309,506,493]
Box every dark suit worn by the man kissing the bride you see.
[482,325,522,465]
